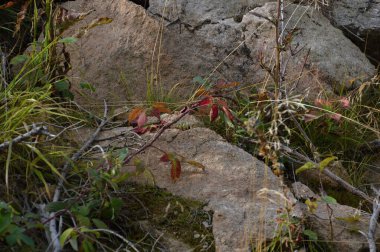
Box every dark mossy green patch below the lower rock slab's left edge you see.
[116,184,215,251]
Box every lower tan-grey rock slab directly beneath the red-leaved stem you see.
[93,126,298,252]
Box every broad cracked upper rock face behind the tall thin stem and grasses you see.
[60,0,375,105]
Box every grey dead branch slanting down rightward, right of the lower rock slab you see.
[280,144,373,202]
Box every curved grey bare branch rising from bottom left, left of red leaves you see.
[49,101,108,252]
